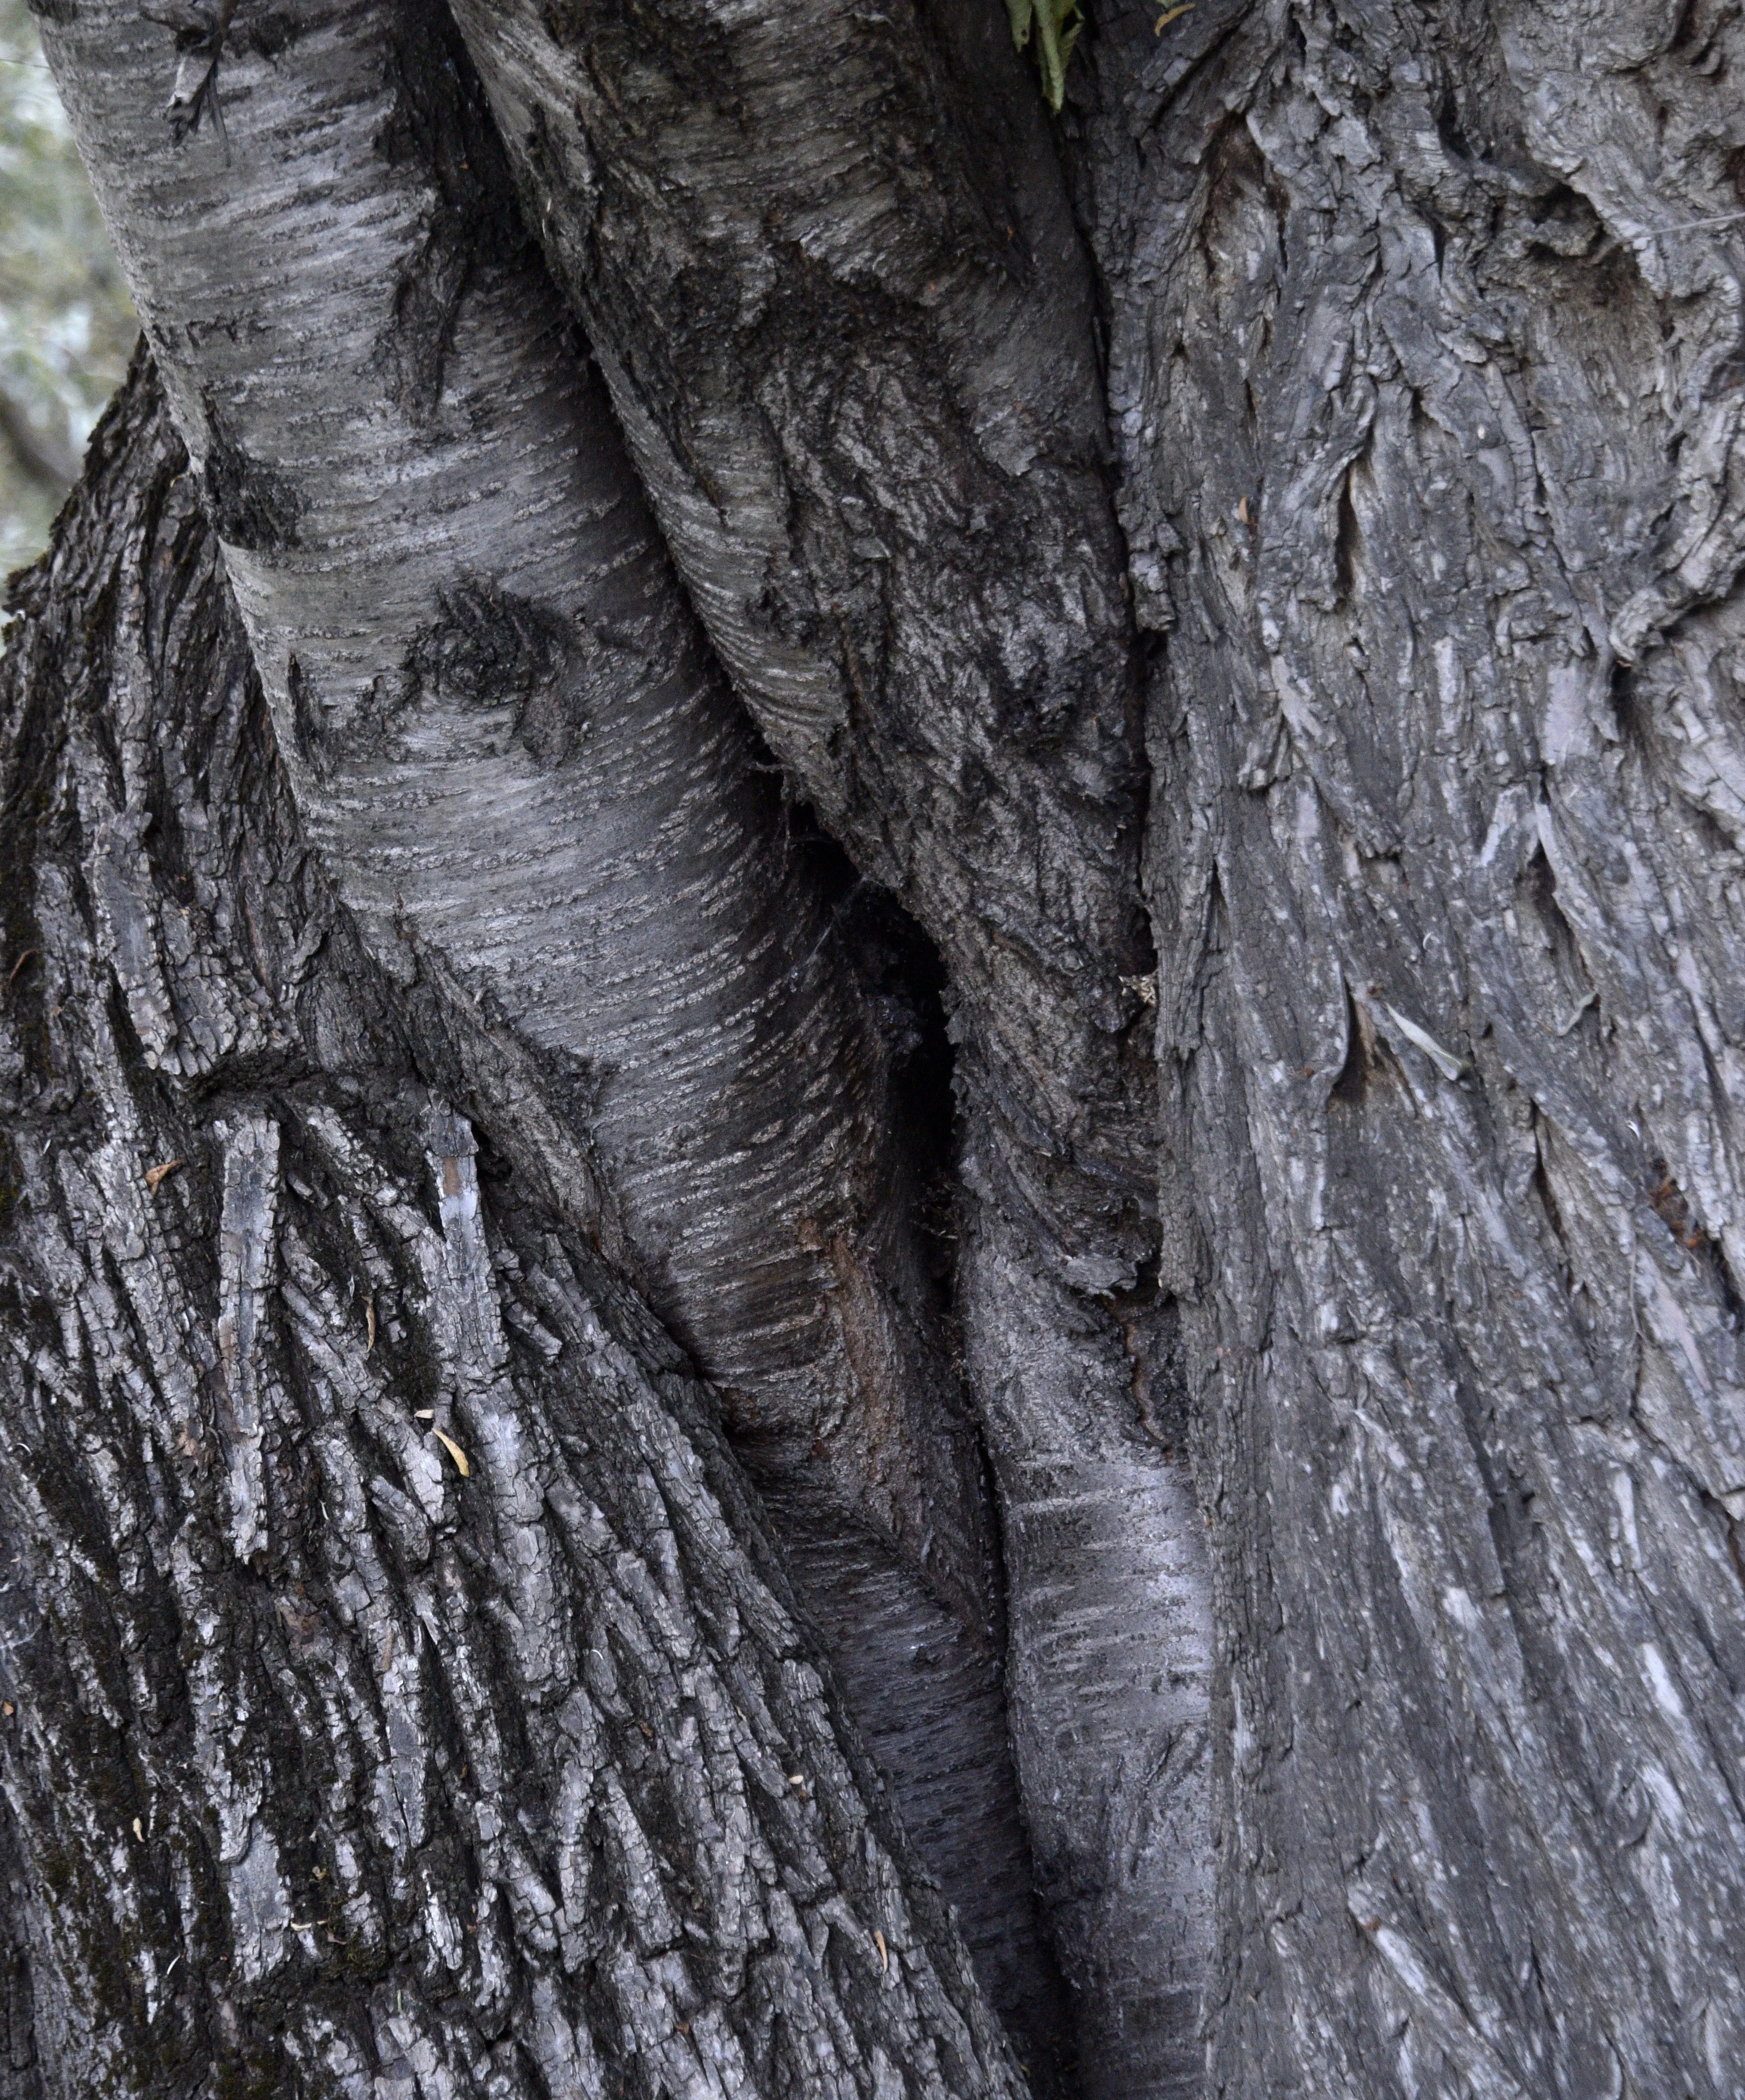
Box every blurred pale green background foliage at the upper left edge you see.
[0,0,139,575]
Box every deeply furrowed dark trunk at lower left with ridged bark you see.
[0,365,1023,2100]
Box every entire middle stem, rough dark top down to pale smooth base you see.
[441,0,1210,2094]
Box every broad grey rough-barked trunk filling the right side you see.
[1077,0,1745,2100]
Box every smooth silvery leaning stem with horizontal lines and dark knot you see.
[46,0,1058,2047]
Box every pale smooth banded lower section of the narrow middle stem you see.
[959,1203,1214,2100]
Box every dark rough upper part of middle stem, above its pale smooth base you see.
[456,0,1151,1289]
